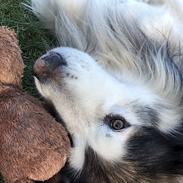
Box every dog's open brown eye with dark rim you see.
[104,114,130,131]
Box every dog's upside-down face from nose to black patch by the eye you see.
[34,48,181,180]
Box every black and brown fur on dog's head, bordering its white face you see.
[50,127,183,183]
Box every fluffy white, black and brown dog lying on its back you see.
[31,0,183,183]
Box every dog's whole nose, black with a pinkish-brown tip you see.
[33,52,67,78]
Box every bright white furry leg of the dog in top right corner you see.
[116,0,183,46]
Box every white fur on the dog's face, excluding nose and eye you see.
[33,48,179,170]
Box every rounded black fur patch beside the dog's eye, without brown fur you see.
[125,127,183,177]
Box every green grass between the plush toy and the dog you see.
[0,0,56,183]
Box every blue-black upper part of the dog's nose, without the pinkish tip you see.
[41,52,67,71]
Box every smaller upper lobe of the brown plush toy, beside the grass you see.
[0,27,24,86]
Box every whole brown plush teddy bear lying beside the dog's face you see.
[0,27,70,183]
